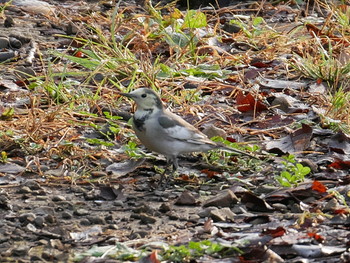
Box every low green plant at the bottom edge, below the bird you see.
[162,240,240,262]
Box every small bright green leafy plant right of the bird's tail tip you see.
[276,154,311,187]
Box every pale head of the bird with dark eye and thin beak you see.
[120,88,163,110]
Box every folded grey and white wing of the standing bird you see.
[158,112,215,145]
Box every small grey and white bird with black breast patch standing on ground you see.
[119,88,256,184]
